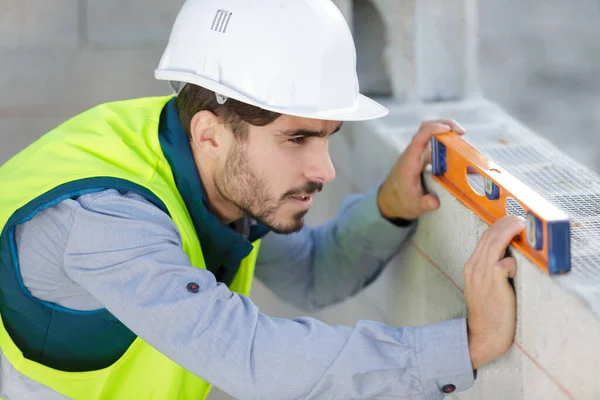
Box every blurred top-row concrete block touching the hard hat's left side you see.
[87,0,184,47]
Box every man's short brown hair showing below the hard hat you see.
[175,83,281,139]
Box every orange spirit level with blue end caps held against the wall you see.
[431,132,571,274]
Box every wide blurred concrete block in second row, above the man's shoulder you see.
[0,49,171,111]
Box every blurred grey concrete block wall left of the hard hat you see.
[0,0,183,162]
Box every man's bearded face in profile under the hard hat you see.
[214,115,341,233]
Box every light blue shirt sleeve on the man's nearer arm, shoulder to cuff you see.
[56,189,473,400]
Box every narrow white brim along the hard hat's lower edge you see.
[154,69,389,121]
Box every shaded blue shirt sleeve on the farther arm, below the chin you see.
[256,186,416,311]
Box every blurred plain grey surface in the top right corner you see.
[479,0,600,172]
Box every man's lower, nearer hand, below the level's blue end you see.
[463,216,525,369]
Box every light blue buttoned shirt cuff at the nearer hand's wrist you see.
[416,318,475,400]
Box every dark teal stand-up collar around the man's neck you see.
[158,98,269,283]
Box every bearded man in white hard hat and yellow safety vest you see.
[0,0,524,400]
